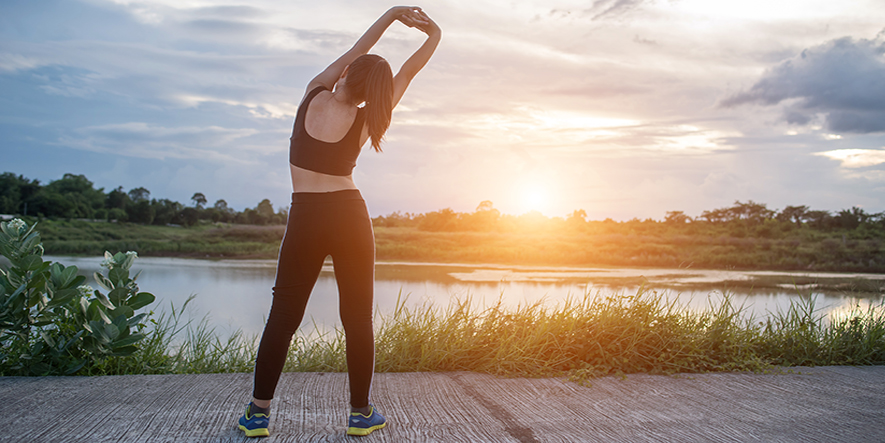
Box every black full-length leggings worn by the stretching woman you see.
[252,189,375,408]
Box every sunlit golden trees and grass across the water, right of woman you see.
[373,201,885,272]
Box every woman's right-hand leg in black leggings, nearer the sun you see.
[332,200,375,408]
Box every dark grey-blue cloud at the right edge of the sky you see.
[720,31,885,133]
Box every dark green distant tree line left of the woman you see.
[0,172,287,226]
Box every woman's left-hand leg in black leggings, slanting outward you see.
[252,204,327,407]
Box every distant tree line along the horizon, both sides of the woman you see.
[0,172,885,238]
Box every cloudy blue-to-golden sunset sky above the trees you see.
[0,0,885,220]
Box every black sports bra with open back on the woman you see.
[289,86,365,175]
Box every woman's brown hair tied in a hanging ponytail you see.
[347,54,393,152]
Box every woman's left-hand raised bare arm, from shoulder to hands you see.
[305,6,426,94]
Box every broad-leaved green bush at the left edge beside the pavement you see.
[0,219,154,375]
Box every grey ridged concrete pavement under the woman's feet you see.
[0,366,885,443]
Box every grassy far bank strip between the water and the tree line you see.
[32,220,885,273]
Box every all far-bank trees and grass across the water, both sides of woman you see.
[0,173,885,272]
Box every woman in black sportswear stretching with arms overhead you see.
[239,6,441,437]
